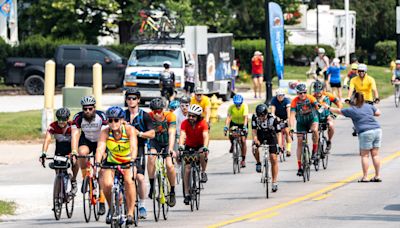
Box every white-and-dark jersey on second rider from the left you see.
[72,110,107,142]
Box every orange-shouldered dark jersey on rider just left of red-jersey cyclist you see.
[149,111,176,146]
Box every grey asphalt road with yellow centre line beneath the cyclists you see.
[0,99,400,228]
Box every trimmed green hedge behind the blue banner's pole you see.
[233,40,335,72]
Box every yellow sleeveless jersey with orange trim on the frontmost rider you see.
[106,124,131,164]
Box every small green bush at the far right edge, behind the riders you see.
[375,40,397,66]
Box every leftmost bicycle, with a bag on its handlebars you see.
[42,155,75,220]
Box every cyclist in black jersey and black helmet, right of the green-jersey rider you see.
[251,104,281,192]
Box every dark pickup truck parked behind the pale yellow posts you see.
[4,45,126,95]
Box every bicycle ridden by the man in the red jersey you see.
[181,148,202,211]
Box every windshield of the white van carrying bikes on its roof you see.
[128,50,182,68]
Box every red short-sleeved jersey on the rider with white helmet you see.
[181,119,208,147]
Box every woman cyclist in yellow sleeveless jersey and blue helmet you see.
[95,106,137,225]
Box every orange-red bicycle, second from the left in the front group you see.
[76,155,100,222]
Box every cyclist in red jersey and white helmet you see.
[179,104,209,205]
